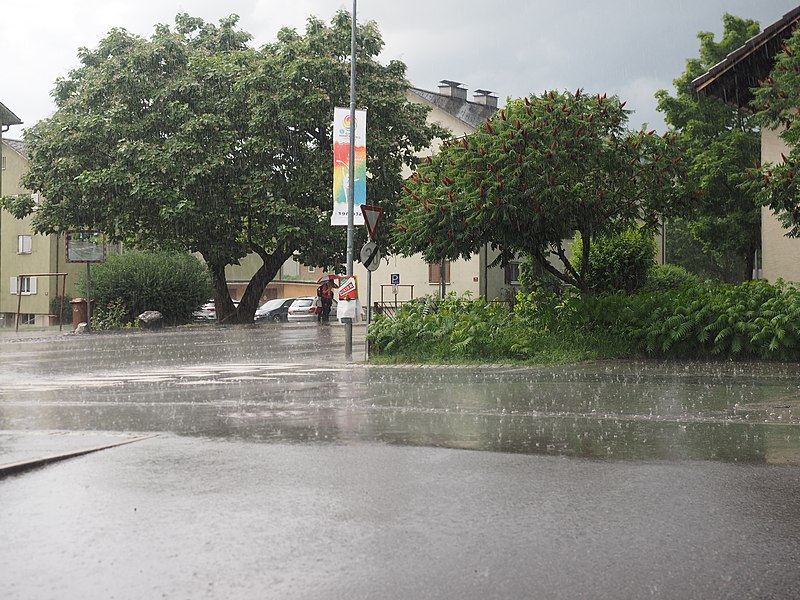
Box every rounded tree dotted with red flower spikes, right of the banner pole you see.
[395,90,687,292]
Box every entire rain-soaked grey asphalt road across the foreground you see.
[0,325,800,599]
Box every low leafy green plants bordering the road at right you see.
[369,280,800,363]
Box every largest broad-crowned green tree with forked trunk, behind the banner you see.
[8,12,440,322]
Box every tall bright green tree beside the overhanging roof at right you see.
[656,14,761,280]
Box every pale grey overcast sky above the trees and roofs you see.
[0,0,800,138]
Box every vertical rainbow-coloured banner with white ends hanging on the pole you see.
[331,107,367,225]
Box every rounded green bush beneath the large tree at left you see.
[79,251,213,326]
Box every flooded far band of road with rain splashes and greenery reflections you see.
[0,326,800,464]
